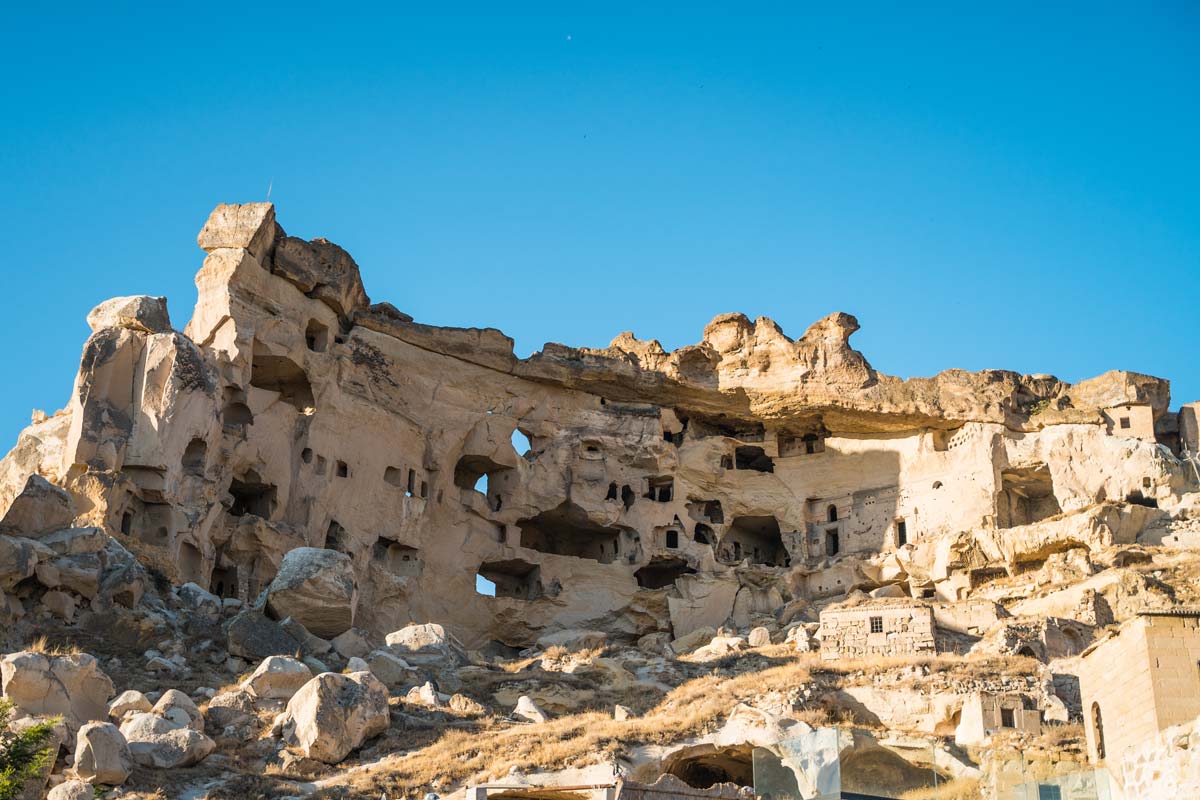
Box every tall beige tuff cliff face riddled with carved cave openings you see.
[0,204,1186,655]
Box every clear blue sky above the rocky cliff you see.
[0,0,1200,447]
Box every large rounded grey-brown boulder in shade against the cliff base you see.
[266,547,359,638]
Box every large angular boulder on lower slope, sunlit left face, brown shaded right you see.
[280,672,390,764]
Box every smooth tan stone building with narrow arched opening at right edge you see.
[1079,608,1200,777]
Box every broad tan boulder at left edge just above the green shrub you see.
[0,651,115,730]
